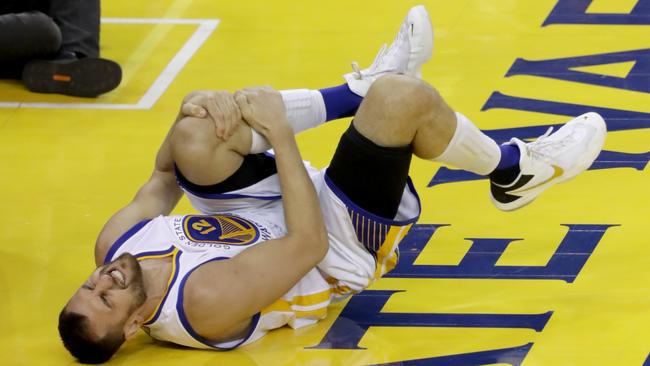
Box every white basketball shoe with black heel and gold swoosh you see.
[490,112,607,211]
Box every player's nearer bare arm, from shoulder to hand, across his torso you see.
[183,89,328,341]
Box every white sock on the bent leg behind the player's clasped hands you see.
[250,89,327,154]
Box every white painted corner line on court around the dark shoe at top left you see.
[0,18,219,110]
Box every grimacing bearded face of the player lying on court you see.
[66,253,147,338]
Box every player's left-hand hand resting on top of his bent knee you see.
[181,90,242,140]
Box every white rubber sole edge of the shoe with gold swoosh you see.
[490,112,607,211]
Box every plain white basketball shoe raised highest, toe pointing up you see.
[343,5,433,97]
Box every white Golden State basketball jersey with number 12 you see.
[105,213,332,350]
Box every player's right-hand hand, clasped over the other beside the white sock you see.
[234,86,293,144]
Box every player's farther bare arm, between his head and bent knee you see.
[95,113,183,265]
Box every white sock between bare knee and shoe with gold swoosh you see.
[433,112,501,175]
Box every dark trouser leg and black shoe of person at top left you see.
[0,0,122,97]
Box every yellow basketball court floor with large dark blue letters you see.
[0,0,650,366]
